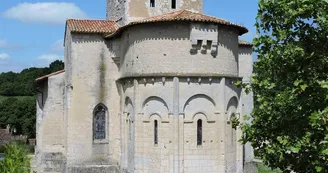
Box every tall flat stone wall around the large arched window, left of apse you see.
[66,34,120,171]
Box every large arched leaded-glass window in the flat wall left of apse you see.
[93,104,107,140]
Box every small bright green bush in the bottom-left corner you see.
[0,143,30,173]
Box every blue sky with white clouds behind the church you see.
[0,0,257,73]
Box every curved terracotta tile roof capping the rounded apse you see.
[106,10,248,38]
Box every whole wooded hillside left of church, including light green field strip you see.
[0,60,64,138]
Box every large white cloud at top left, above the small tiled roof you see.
[2,2,87,24]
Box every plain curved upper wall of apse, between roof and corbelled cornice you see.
[120,23,238,77]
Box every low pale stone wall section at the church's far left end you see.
[36,73,66,172]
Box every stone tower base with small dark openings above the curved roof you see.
[107,0,204,25]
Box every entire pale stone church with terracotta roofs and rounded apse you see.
[35,0,253,173]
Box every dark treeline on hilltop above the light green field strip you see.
[0,60,64,96]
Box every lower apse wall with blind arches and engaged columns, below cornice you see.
[121,77,242,173]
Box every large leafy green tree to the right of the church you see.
[242,0,328,173]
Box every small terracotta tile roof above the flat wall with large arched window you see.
[66,19,119,34]
